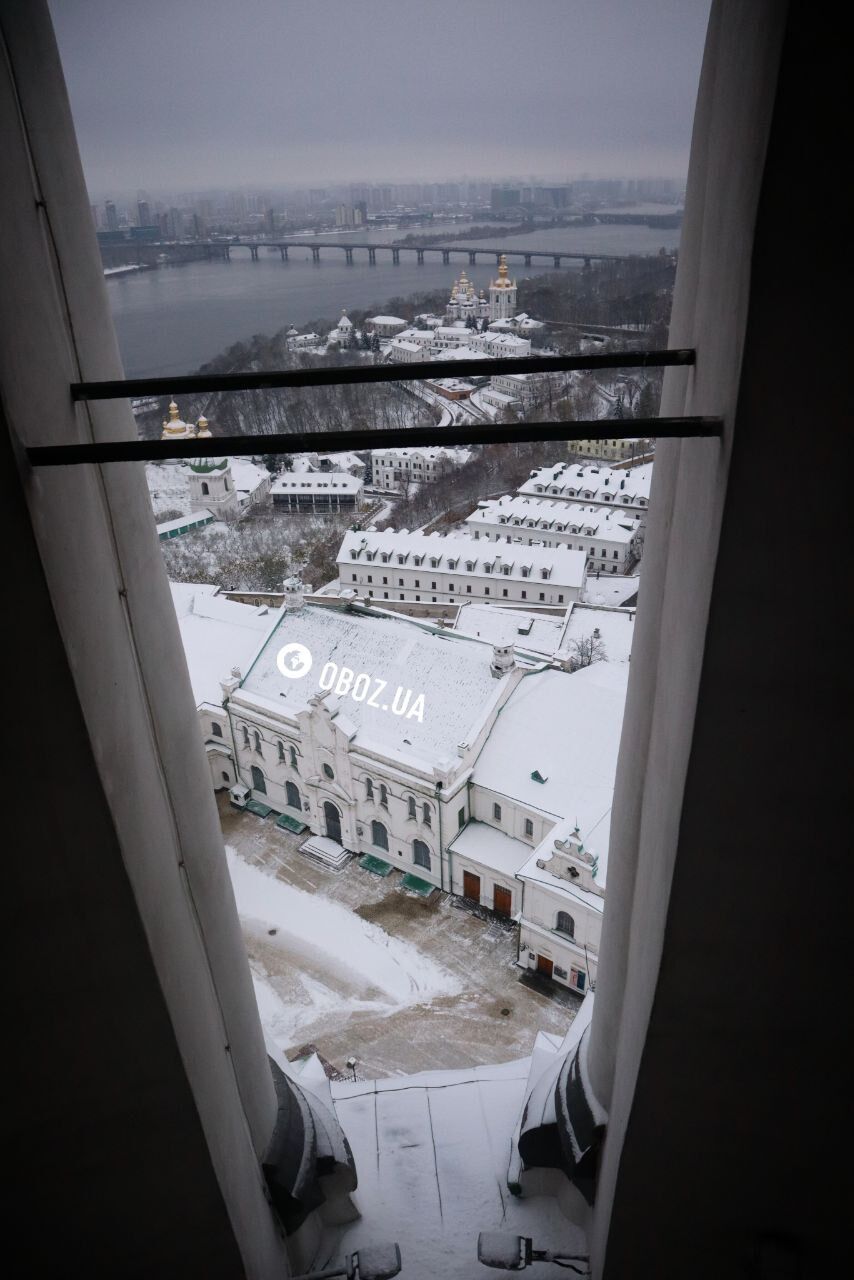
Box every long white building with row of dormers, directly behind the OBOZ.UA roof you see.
[338,527,586,605]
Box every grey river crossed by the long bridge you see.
[106,213,679,378]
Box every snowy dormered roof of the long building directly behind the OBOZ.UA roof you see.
[338,527,586,586]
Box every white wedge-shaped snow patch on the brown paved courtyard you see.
[225,845,460,1047]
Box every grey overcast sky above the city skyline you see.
[51,0,708,198]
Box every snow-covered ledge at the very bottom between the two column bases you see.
[332,1054,589,1280]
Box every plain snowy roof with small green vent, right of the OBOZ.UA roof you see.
[474,662,629,869]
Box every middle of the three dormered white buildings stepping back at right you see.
[466,494,643,573]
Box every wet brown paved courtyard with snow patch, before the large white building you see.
[219,795,580,1080]
